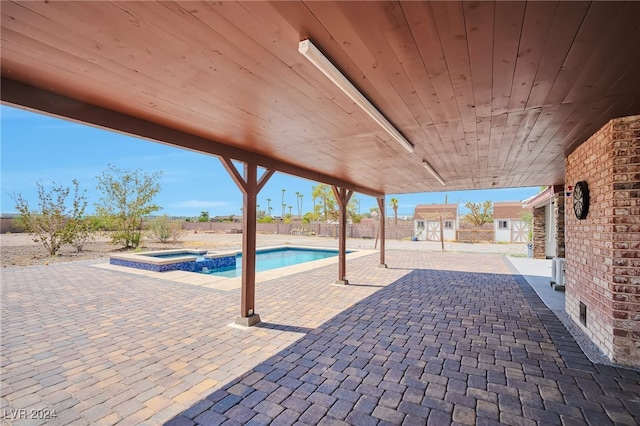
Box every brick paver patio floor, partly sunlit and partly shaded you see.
[0,250,640,425]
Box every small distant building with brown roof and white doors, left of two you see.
[413,204,460,241]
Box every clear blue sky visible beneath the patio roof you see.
[0,105,539,216]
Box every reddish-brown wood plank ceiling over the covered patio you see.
[1,1,640,193]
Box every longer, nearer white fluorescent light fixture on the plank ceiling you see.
[298,39,413,152]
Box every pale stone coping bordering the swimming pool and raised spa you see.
[93,244,379,291]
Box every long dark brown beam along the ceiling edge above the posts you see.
[0,76,384,198]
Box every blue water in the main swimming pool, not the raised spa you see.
[201,247,348,278]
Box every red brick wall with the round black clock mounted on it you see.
[565,116,640,366]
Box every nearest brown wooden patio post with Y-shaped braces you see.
[220,157,275,327]
